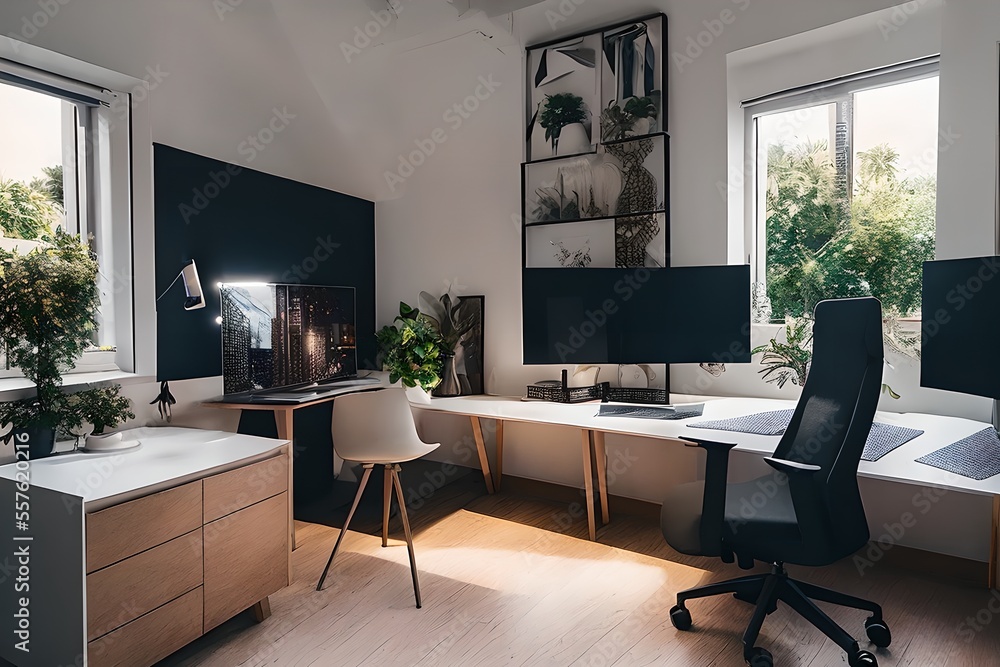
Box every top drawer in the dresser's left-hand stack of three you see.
[87,480,202,573]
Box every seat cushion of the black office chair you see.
[660,475,801,562]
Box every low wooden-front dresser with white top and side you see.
[0,429,291,667]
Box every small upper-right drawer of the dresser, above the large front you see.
[204,455,288,523]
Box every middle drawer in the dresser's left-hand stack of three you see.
[87,528,203,640]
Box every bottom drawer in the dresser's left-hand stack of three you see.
[87,588,204,667]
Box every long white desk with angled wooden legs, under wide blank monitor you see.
[412,396,1000,587]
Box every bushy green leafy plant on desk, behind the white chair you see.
[375,301,444,391]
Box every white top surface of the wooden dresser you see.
[0,427,287,511]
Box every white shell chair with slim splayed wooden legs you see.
[316,388,440,609]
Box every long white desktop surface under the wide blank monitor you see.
[411,395,1000,495]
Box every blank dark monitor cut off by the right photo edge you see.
[920,257,1000,398]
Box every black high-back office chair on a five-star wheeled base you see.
[660,298,892,667]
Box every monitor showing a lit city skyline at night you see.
[220,283,357,394]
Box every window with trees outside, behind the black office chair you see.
[744,59,938,321]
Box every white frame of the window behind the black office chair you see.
[740,56,941,300]
